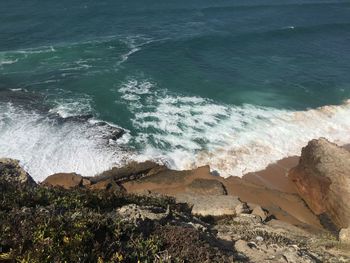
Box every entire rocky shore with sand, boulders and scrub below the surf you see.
[0,138,350,262]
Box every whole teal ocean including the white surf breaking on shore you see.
[0,0,350,181]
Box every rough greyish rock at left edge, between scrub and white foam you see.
[0,158,36,186]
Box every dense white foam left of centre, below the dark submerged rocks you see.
[0,103,131,181]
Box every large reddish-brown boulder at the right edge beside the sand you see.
[289,138,350,228]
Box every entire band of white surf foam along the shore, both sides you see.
[0,76,350,181]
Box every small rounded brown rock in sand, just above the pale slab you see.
[186,179,227,195]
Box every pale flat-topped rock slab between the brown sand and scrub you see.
[176,194,241,216]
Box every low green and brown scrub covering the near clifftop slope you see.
[0,165,235,263]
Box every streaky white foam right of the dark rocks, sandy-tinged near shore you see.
[119,78,350,176]
